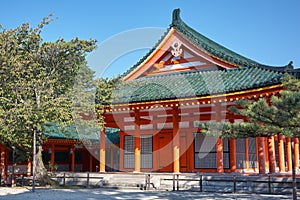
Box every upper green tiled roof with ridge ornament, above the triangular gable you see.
[123,9,300,76]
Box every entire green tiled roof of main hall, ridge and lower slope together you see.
[113,9,300,104]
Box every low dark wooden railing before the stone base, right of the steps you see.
[162,174,300,194]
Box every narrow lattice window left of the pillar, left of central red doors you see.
[124,135,134,168]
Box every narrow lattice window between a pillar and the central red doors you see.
[140,135,153,168]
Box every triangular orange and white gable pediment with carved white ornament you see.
[125,28,237,80]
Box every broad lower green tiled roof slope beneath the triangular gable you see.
[114,67,284,104]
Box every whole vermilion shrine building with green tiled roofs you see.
[0,9,300,175]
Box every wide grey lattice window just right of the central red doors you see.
[194,133,216,168]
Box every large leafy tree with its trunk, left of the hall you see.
[0,16,96,185]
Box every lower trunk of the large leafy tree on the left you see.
[35,145,51,186]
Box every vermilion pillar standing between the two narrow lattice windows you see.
[134,111,141,172]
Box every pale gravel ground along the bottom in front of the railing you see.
[0,187,292,200]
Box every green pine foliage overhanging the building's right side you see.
[198,75,300,138]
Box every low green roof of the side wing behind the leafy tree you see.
[44,123,120,144]
